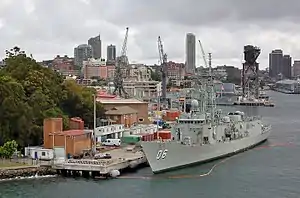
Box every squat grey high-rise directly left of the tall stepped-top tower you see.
[74,44,93,68]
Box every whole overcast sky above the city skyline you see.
[0,0,300,68]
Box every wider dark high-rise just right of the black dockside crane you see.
[269,49,283,78]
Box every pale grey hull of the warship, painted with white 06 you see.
[142,129,271,173]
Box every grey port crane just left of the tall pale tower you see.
[157,36,168,101]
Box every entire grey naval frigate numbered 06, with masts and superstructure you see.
[141,74,271,173]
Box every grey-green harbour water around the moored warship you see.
[0,92,300,198]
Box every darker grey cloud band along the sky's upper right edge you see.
[96,0,300,26]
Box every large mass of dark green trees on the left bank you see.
[0,47,103,147]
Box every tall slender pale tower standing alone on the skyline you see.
[185,33,196,74]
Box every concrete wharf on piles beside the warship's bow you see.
[52,148,147,177]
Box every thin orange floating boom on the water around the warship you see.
[118,142,295,180]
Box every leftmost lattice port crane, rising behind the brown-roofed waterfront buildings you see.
[113,27,129,98]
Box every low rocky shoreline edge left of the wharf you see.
[0,166,56,181]
